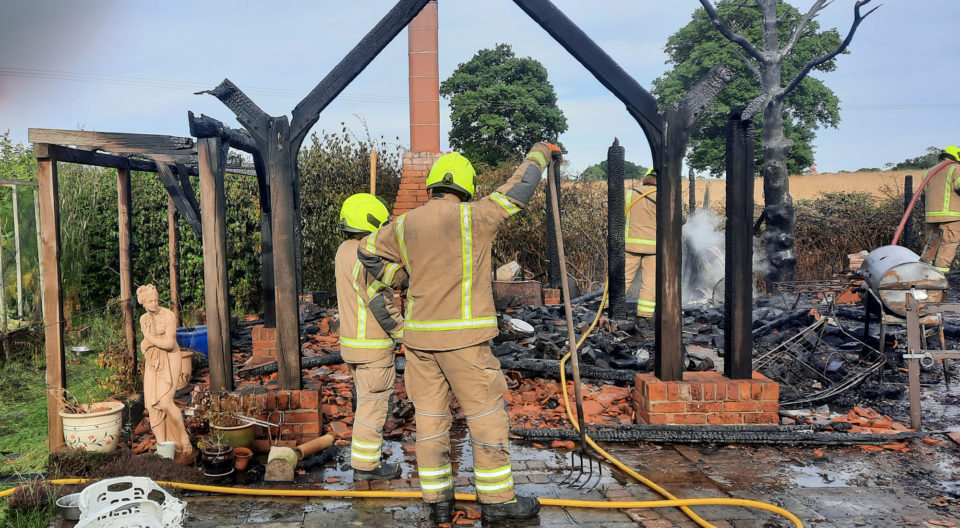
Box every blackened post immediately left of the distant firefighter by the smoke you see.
[607,139,627,321]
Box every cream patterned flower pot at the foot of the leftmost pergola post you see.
[59,401,124,453]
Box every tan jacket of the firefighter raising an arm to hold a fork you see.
[360,143,550,350]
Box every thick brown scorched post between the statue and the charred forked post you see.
[197,137,233,392]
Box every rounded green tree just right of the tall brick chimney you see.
[440,44,567,166]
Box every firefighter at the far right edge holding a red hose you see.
[922,145,960,273]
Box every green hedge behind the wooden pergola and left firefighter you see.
[0,127,401,322]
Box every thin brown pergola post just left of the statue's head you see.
[117,169,137,377]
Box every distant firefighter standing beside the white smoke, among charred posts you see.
[625,169,657,322]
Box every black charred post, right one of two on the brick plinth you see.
[723,106,754,379]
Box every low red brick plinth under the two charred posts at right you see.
[633,371,780,425]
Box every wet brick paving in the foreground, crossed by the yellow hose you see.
[176,420,960,528]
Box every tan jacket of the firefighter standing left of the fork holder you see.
[334,238,407,363]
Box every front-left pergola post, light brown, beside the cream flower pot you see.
[34,147,67,451]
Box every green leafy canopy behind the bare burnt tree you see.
[653,0,841,176]
